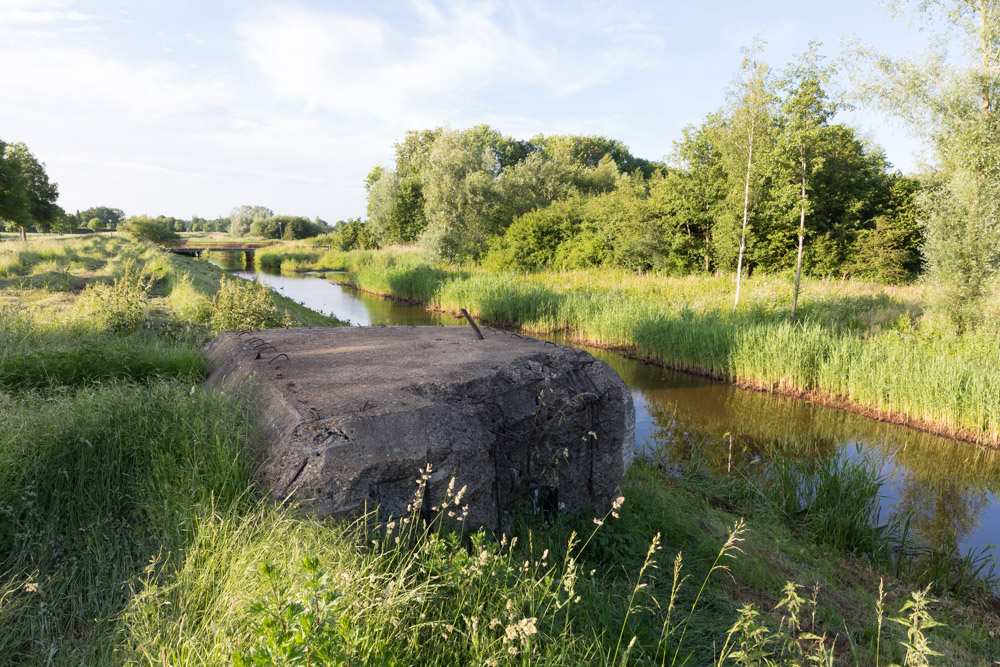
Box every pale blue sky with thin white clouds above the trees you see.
[0,0,936,222]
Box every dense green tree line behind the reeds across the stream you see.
[358,64,922,288]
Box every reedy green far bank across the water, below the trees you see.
[258,246,1000,448]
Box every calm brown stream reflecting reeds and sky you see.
[235,271,1000,572]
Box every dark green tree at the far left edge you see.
[0,142,60,239]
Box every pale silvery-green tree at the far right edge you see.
[857,0,1000,331]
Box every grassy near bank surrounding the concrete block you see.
[0,237,1000,665]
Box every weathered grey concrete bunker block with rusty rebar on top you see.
[206,327,635,529]
